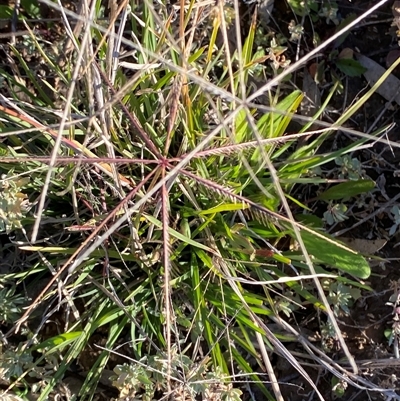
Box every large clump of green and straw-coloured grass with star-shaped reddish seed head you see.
[0,1,396,400]
